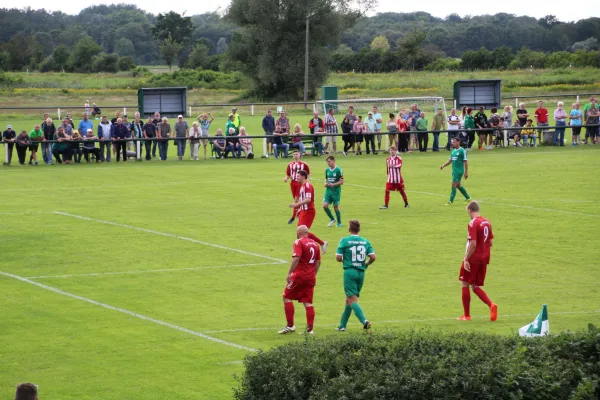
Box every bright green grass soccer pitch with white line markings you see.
[0,142,600,400]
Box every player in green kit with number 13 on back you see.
[335,219,375,331]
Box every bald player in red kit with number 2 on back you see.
[279,225,321,335]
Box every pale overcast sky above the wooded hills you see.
[0,0,600,22]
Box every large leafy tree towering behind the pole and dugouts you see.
[226,0,376,98]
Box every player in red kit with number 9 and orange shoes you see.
[458,201,498,322]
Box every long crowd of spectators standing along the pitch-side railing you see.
[2,96,600,165]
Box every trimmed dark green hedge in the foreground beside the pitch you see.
[234,328,600,400]
